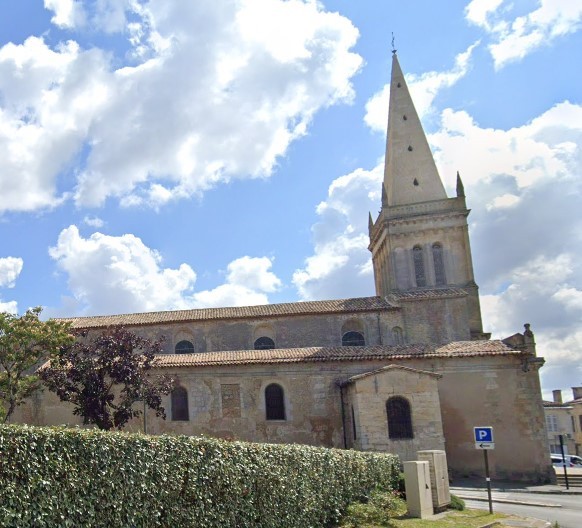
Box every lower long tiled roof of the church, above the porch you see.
[156,341,525,368]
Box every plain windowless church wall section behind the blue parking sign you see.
[440,357,554,481]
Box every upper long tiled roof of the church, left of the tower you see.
[59,297,398,328]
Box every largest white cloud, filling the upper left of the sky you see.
[0,0,361,211]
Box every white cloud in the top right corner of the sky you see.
[465,0,582,68]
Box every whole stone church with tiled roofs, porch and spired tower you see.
[20,54,553,481]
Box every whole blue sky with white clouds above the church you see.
[0,0,582,393]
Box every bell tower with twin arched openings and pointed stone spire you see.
[369,51,483,339]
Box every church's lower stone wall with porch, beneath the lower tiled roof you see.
[13,356,553,481]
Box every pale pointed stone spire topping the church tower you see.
[384,53,447,206]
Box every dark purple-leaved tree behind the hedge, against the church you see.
[40,326,173,430]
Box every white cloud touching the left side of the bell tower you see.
[293,165,383,300]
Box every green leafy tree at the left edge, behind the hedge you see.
[0,307,74,422]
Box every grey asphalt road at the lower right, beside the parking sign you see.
[454,490,582,528]
